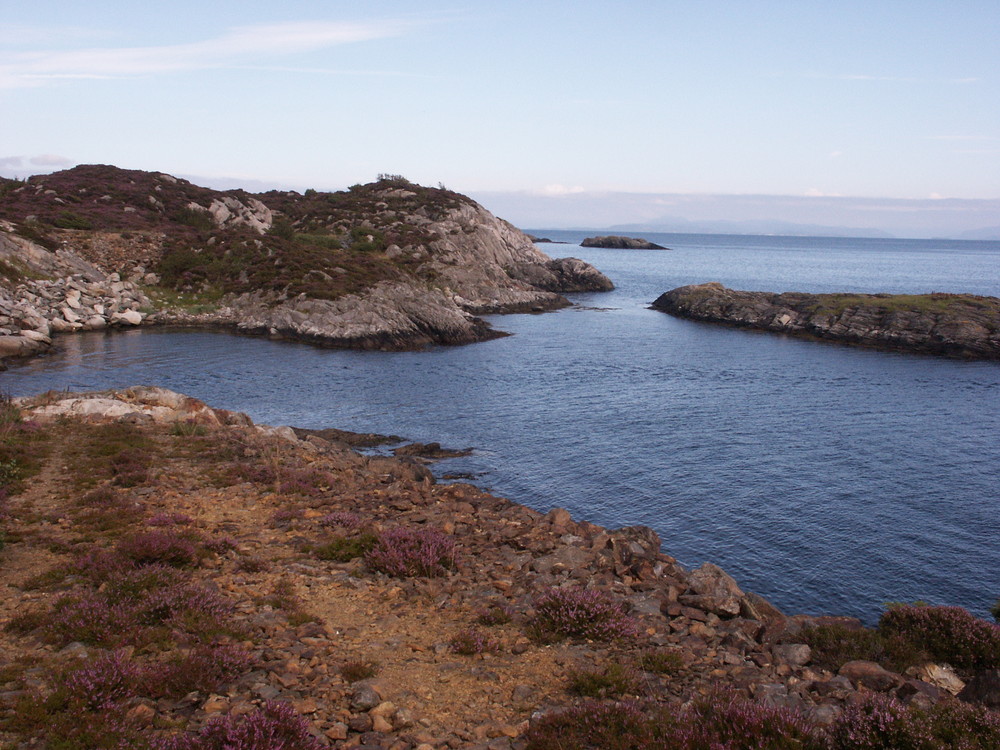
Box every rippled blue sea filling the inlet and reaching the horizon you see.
[0,234,1000,623]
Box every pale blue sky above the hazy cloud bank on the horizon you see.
[0,0,1000,235]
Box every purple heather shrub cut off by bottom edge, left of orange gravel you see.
[153,701,324,750]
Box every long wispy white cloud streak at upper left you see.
[0,21,410,88]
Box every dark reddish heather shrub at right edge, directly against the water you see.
[879,605,1000,669]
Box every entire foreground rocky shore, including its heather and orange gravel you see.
[0,387,1000,750]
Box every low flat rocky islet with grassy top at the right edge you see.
[653,282,1000,359]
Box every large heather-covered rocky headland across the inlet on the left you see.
[0,165,613,366]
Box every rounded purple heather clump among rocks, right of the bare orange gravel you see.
[528,588,637,641]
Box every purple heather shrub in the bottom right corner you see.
[831,695,1000,750]
